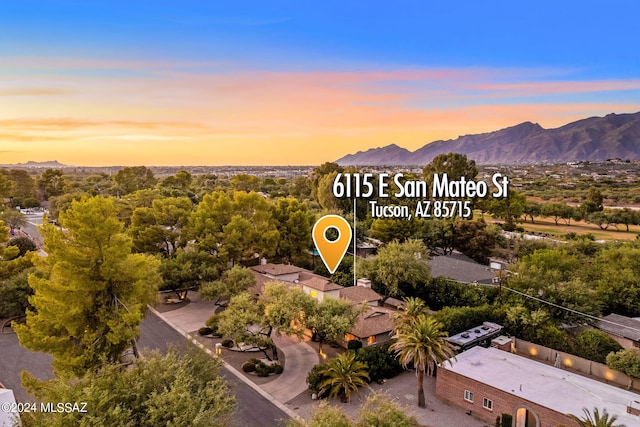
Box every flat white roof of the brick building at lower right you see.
[444,347,640,426]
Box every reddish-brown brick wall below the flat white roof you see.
[436,369,582,427]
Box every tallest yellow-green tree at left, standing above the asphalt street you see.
[16,197,161,375]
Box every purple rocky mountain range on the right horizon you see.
[336,112,640,166]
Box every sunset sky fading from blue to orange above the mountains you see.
[0,0,640,166]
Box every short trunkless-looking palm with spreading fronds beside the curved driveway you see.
[320,351,369,402]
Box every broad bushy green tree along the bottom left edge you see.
[22,348,235,427]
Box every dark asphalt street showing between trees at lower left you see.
[0,313,289,427]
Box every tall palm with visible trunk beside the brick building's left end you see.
[389,314,455,408]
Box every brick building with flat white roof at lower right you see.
[436,347,640,427]
